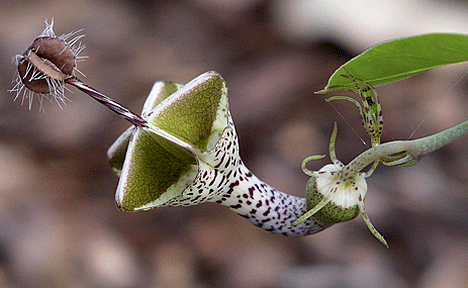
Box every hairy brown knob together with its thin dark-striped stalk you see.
[10,21,148,127]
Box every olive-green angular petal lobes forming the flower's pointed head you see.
[108,72,230,211]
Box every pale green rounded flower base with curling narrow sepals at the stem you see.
[293,122,388,248]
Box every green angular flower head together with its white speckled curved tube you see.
[108,72,332,236]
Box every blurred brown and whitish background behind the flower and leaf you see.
[0,0,468,288]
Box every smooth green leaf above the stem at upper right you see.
[316,33,468,94]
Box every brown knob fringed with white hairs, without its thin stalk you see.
[10,20,86,109]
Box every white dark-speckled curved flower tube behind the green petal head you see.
[152,108,333,236]
